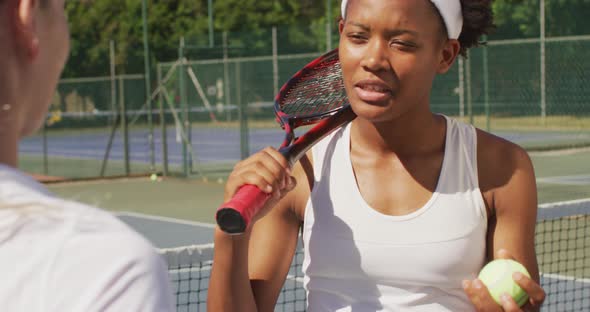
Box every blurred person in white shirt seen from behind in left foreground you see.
[0,0,173,311]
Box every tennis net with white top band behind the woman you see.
[160,199,590,312]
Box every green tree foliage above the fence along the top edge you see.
[64,0,590,77]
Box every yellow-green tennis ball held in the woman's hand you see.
[479,259,531,306]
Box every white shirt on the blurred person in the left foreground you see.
[0,165,174,312]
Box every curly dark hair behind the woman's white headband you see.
[460,0,496,57]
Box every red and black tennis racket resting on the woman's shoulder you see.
[216,49,356,234]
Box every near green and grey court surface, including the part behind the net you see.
[49,143,590,311]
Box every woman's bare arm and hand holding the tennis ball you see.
[464,132,545,312]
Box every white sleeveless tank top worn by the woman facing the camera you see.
[303,116,487,312]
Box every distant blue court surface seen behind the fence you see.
[19,126,590,164]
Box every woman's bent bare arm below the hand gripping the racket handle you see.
[207,150,309,312]
